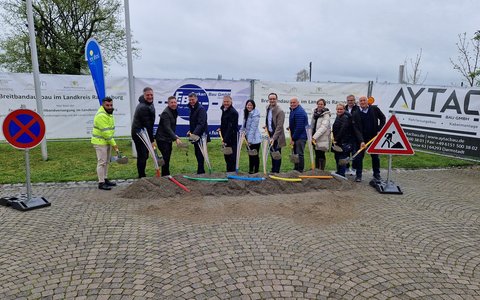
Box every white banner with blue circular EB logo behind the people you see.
[135,78,251,137]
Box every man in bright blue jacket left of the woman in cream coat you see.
[289,97,308,172]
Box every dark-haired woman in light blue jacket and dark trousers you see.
[243,100,262,174]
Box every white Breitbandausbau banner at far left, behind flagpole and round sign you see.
[0,73,131,141]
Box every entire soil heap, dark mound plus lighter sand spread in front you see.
[117,170,358,224]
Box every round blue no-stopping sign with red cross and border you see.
[2,109,45,149]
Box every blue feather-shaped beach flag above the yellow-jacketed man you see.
[85,38,105,105]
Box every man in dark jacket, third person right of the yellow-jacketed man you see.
[188,93,210,174]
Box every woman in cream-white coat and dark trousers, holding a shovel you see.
[310,99,331,170]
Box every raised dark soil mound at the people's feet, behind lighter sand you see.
[120,170,352,199]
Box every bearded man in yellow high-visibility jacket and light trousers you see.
[91,97,118,191]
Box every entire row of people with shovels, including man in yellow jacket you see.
[91,87,385,190]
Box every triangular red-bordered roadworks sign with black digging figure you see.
[367,115,415,155]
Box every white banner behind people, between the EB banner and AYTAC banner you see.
[254,81,368,128]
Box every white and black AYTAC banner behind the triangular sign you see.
[373,84,480,159]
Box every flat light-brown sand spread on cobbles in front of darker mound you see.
[137,190,356,225]
